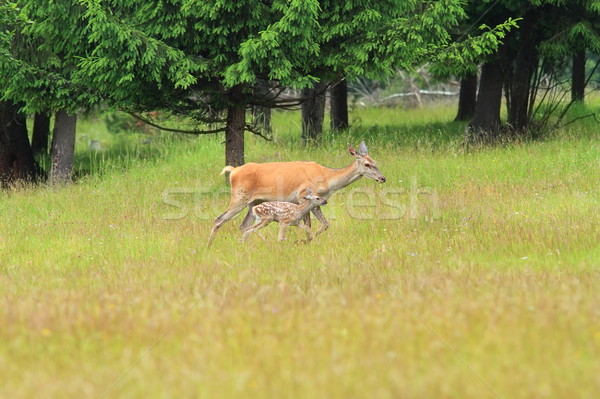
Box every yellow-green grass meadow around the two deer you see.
[0,107,600,399]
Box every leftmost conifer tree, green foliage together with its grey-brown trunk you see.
[0,0,100,182]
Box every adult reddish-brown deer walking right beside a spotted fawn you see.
[208,141,386,247]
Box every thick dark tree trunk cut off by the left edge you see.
[0,101,38,187]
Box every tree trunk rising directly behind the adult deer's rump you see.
[225,85,246,166]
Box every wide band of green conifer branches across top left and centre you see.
[1,0,510,121]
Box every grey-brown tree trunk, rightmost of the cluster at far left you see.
[50,110,77,184]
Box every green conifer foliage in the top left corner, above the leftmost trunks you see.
[0,0,100,112]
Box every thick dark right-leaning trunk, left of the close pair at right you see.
[466,60,504,144]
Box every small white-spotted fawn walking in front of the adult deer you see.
[242,187,327,241]
